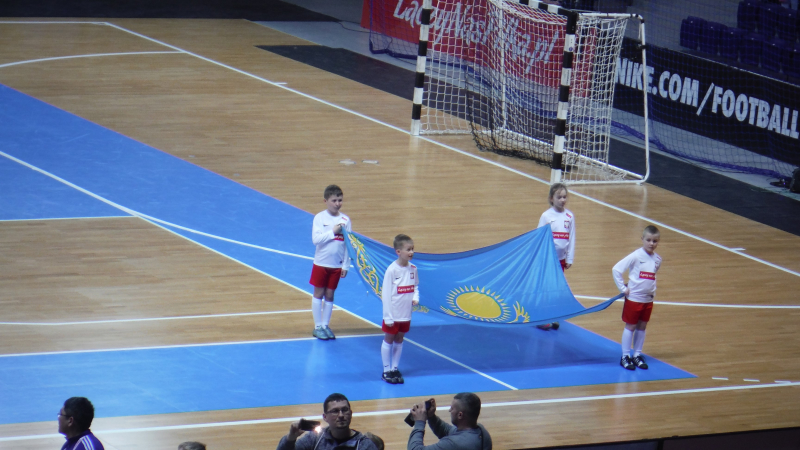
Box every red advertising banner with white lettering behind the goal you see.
[361,0,566,87]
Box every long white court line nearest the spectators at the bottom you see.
[0,382,800,442]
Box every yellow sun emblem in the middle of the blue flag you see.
[442,286,511,322]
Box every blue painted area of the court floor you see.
[0,86,693,424]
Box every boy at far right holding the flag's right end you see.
[611,225,661,370]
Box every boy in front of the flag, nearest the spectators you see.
[381,234,419,384]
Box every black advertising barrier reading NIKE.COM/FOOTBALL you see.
[614,38,800,171]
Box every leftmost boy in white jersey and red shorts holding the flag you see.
[309,184,353,341]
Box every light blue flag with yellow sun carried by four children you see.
[346,226,622,325]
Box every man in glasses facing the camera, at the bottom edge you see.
[278,394,377,450]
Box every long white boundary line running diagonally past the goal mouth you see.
[3,22,800,277]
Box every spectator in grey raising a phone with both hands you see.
[408,392,492,450]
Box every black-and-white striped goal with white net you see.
[411,0,650,183]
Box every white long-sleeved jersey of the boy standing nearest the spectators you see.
[381,261,419,323]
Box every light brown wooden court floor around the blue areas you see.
[0,19,800,450]
